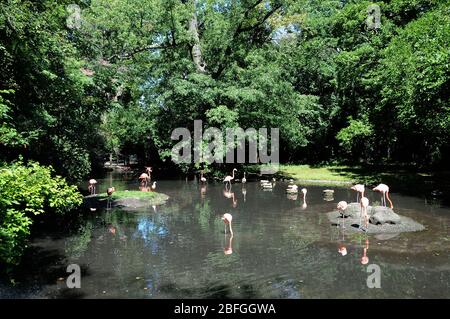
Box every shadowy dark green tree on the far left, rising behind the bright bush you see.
[0,0,107,180]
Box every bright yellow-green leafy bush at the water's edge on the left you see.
[0,162,82,264]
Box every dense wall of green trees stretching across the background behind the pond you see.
[0,0,450,175]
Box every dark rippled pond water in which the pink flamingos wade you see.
[0,175,450,298]
